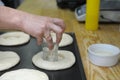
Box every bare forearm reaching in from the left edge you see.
[0,6,25,30]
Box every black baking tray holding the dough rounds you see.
[0,33,86,80]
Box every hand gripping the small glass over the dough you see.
[22,15,65,49]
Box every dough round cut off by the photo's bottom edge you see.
[0,69,49,80]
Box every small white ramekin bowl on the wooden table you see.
[88,44,120,67]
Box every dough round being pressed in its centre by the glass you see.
[32,50,75,70]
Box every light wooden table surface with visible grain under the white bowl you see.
[18,0,120,80]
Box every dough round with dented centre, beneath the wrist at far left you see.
[0,31,30,46]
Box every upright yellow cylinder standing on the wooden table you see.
[85,0,100,30]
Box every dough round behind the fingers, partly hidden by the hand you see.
[51,32,73,47]
